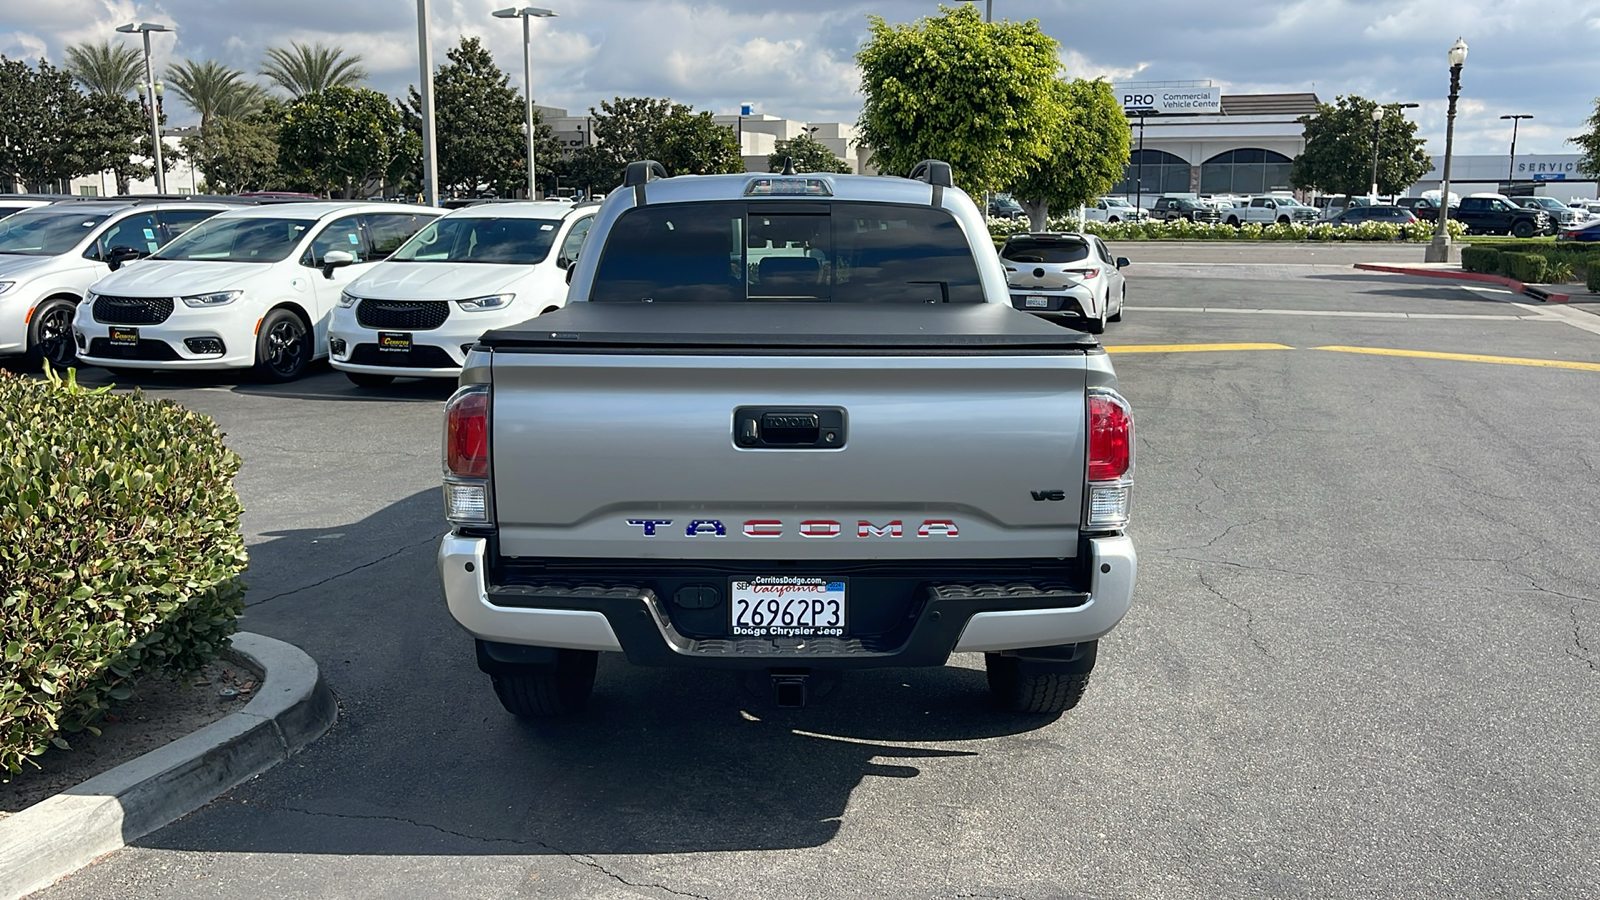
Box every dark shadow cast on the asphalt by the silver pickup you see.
[138,490,1070,857]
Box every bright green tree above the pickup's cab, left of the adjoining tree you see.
[856,3,1061,194]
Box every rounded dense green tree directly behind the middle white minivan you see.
[280,88,406,197]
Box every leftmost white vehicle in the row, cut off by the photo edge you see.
[0,200,238,367]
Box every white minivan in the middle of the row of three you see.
[74,200,442,381]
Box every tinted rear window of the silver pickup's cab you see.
[589,202,984,303]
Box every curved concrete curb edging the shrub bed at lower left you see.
[0,633,339,900]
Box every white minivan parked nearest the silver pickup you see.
[328,200,600,388]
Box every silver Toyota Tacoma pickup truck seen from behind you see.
[438,162,1136,716]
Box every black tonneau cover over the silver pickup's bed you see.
[482,301,1096,352]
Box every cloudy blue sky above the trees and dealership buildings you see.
[0,0,1600,155]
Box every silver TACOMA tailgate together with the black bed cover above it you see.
[485,304,1098,560]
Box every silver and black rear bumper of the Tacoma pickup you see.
[438,535,1138,668]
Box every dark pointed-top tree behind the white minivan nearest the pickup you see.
[405,37,562,197]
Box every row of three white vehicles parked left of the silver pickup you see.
[0,199,595,386]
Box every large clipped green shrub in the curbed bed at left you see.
[0,370,246,778]
